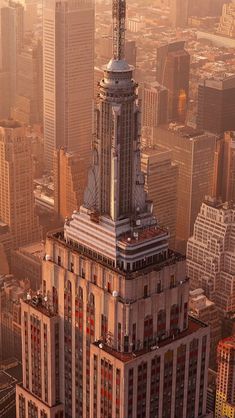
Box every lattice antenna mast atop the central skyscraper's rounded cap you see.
[113,0,126,60]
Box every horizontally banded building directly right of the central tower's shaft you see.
[141,147,178,249]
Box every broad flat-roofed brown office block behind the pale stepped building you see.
[155,124,217,253]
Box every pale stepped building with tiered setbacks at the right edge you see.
[187,198,235,316]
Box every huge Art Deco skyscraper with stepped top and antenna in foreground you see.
[17,0,209,418]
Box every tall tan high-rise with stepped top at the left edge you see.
[0,121,41,250]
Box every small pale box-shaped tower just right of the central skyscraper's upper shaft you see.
[139,81,168,146]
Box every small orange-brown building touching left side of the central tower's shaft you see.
[54,149,87,220]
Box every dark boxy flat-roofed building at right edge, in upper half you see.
[197,76,235,135]
